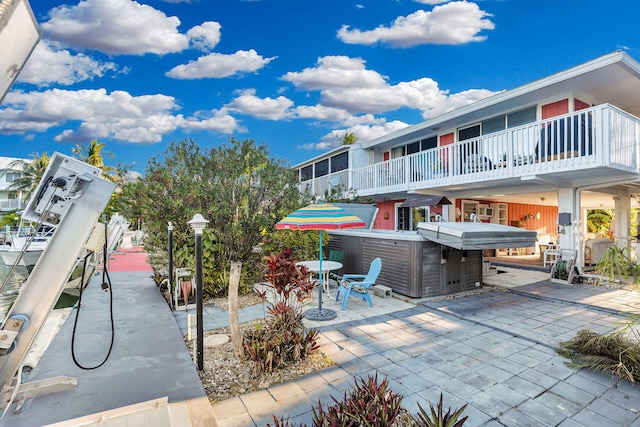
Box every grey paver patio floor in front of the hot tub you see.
[209,269,640,427]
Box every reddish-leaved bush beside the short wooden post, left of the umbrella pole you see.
[243,252,319,376]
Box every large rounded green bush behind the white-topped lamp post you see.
[116,138,306,296]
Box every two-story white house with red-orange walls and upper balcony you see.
[294,51,640,268]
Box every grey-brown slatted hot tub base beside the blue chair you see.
[328,229,482,298]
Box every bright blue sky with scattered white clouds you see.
[0,0,640,172]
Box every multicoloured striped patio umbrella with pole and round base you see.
[276,203,366,320]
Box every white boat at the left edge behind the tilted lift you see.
[0,219,54,268]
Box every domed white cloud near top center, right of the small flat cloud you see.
[281,56,386,90]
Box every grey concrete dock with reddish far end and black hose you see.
[0,247,216,427]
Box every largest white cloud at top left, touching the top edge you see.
[41,0,189,55]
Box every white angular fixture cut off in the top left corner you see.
[0,0,40,103]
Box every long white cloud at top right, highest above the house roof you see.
[338,1,495,47]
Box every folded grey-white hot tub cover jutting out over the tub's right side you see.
[417,222,537,250]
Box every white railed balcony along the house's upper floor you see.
[301,104,640,196]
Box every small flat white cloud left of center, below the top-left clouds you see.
[166,49,276,79]
